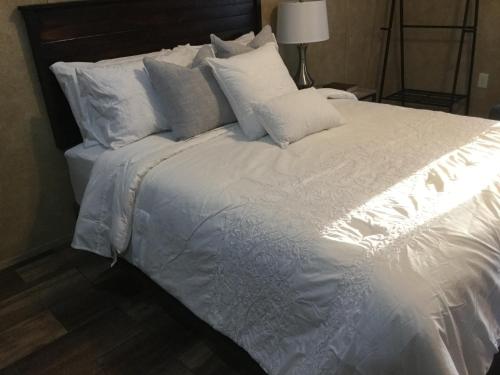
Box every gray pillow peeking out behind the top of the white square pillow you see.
[210,25,276,59]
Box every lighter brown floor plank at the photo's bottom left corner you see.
[0,311,66,368]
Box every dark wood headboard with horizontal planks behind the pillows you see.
[19,0,261,150]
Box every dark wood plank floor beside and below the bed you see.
[0,248,500,375]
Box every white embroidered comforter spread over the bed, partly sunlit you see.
[73,101,500,375]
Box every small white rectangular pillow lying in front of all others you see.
[253,88,344,148]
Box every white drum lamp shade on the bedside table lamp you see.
[277,0,330,44]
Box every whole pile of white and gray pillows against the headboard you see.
[51,26,343,149]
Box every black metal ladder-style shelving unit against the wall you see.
[379,0,479,114]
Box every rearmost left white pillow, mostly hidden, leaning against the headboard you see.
[50,45,197,147]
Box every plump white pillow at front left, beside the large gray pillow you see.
[76,61,164,149]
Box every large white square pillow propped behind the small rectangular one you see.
[207,43,297,140]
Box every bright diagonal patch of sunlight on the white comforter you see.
[321,126,500,252]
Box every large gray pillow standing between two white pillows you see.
[144,54,236,140]
